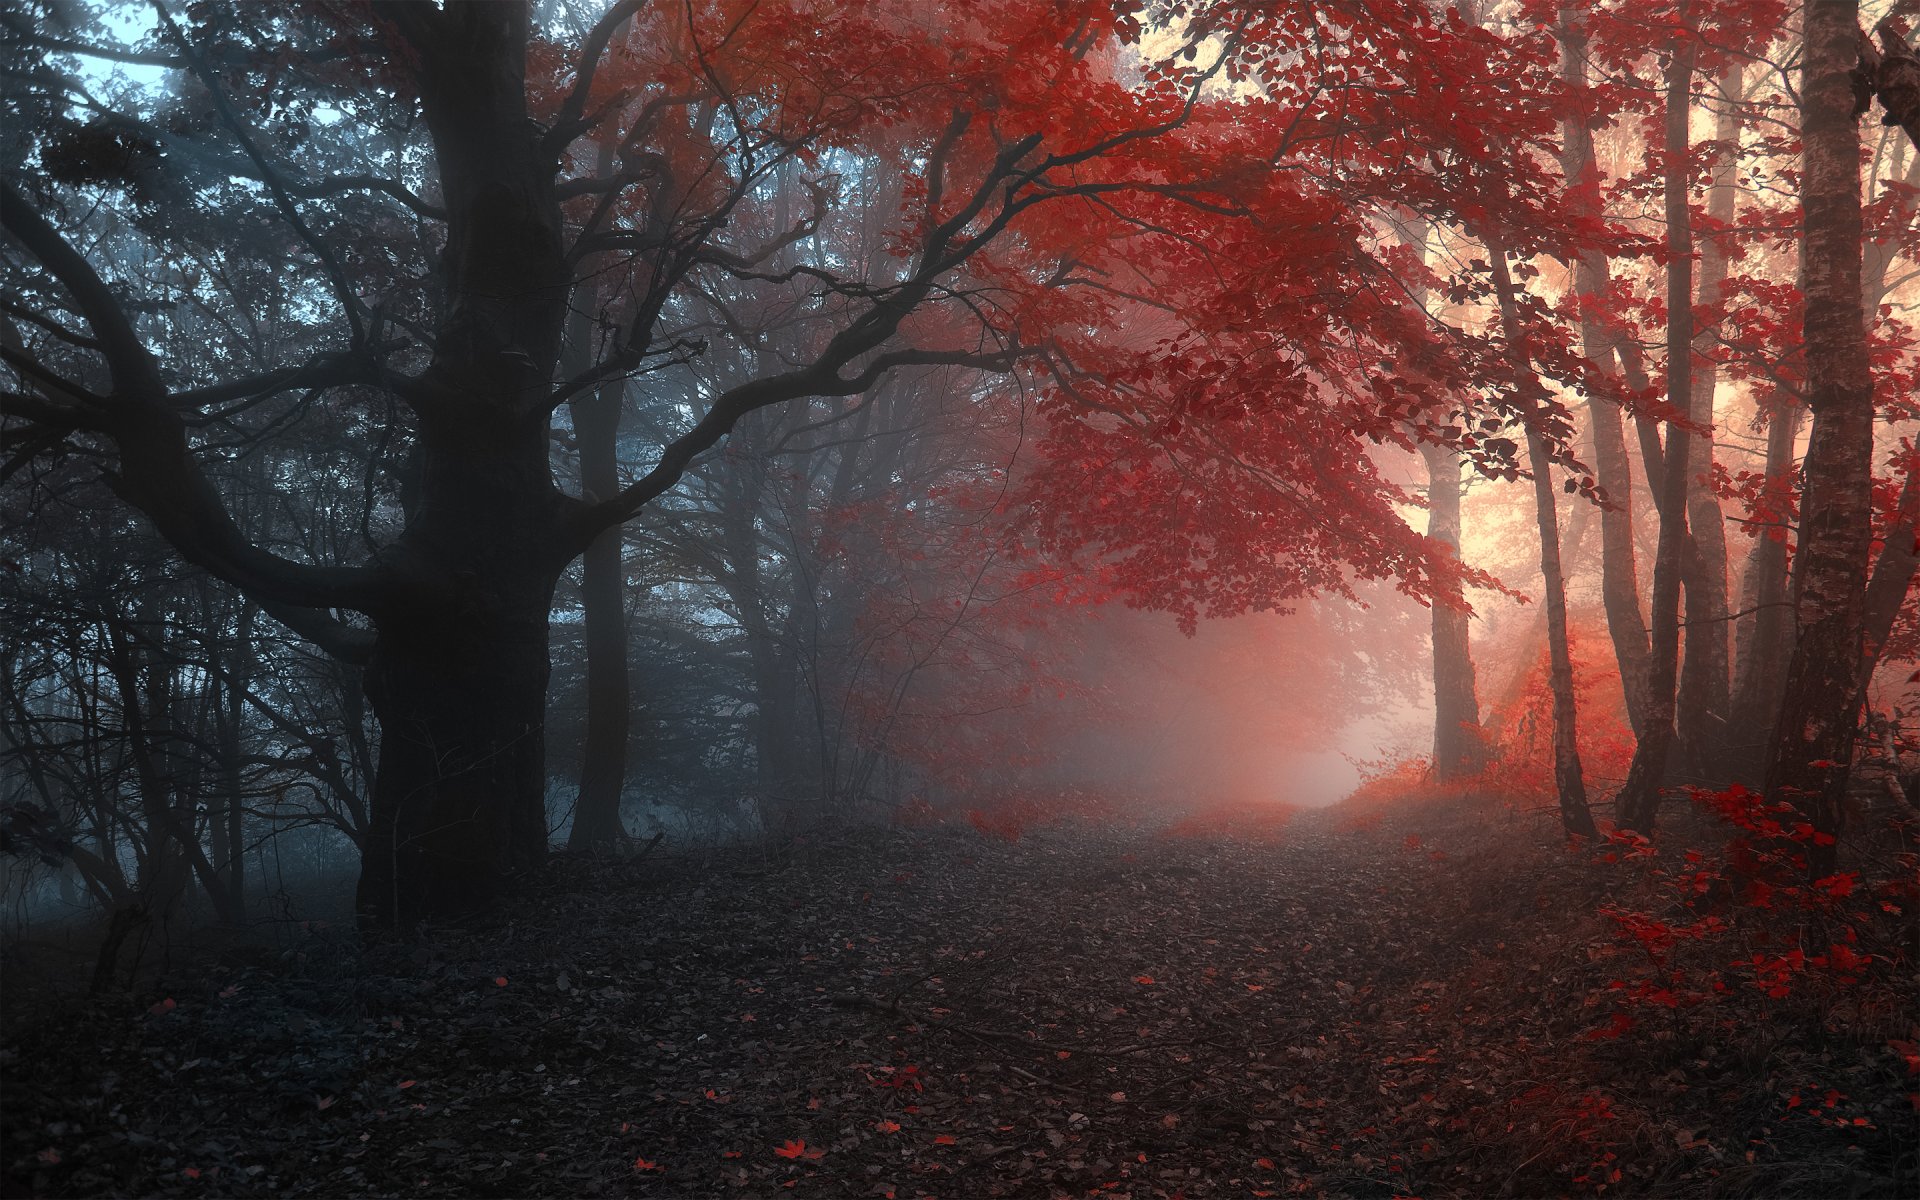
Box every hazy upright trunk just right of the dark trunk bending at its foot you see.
[1674,65,1745,780]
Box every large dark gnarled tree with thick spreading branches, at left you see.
[0,0,1244,925]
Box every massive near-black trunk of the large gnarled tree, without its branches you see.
[359,4,572,925]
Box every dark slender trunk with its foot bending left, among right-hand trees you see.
[1615,35,1693,833]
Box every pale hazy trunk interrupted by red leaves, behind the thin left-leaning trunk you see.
[1559,8,1651,737]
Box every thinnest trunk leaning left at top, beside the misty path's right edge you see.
[1482,234,1599,837]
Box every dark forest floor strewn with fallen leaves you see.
[0,801,1920,1200]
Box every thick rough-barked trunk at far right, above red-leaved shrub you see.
[1766,0,1874,876]
